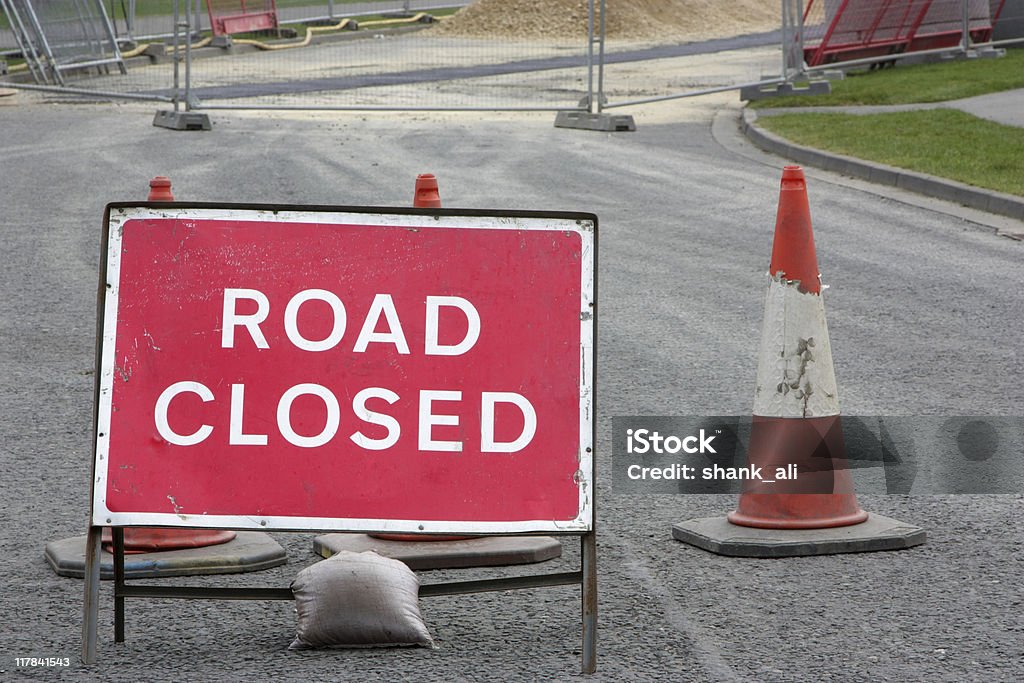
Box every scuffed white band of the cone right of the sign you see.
[754,273,839,418]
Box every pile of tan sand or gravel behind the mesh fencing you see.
[432,0,781,42]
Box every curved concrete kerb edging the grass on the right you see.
[740,108,1024,220]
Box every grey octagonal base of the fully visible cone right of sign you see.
[672,515,928,557]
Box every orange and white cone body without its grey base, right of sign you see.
[729,166,867,528]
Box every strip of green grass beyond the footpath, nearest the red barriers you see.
[751,48,1024,109]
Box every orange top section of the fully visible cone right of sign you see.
[769,166,821,294]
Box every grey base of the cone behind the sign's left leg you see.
[46,531,288,579]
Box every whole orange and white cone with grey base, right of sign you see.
[673,166,927,557]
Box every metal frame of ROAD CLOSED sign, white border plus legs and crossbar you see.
[82,203,597,673]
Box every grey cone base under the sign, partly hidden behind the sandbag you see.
[313,533,562,569]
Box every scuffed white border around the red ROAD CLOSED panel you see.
[91,206,597,535]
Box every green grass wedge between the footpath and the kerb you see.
[758,109,1024,196]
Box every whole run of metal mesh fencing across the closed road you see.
[6,0,1024,111]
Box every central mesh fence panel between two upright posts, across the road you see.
[189,0,589,111]
